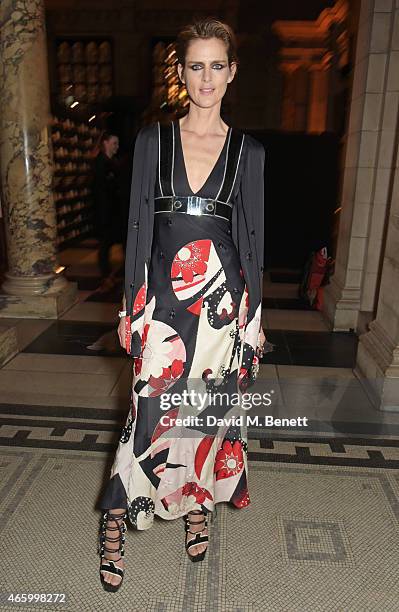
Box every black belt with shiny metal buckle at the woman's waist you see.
[154,196,232,221]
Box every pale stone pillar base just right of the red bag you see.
[322,277,360,331]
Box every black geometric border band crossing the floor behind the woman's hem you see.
[0,404,399,470]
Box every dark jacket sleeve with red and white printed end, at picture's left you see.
[125,126,151,357]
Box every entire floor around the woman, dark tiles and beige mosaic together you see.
[0,243,399,612]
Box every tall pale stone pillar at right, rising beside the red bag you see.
[324,0,399,333]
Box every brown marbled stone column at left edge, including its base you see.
[0,0,76,318]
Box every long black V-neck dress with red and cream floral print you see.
[101,120,263,530]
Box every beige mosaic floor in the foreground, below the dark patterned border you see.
[0,448,399,612]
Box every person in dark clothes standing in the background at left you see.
[93,132,123,279]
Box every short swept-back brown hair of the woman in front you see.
[176,17,238,66]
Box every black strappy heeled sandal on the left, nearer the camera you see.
[99,510,127,592]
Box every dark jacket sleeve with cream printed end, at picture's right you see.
[236,135,265,390]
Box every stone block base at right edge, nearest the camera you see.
[354,321,399,412]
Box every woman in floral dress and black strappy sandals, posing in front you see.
[100,19,271,591]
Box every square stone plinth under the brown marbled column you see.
[0,281,78,319]
